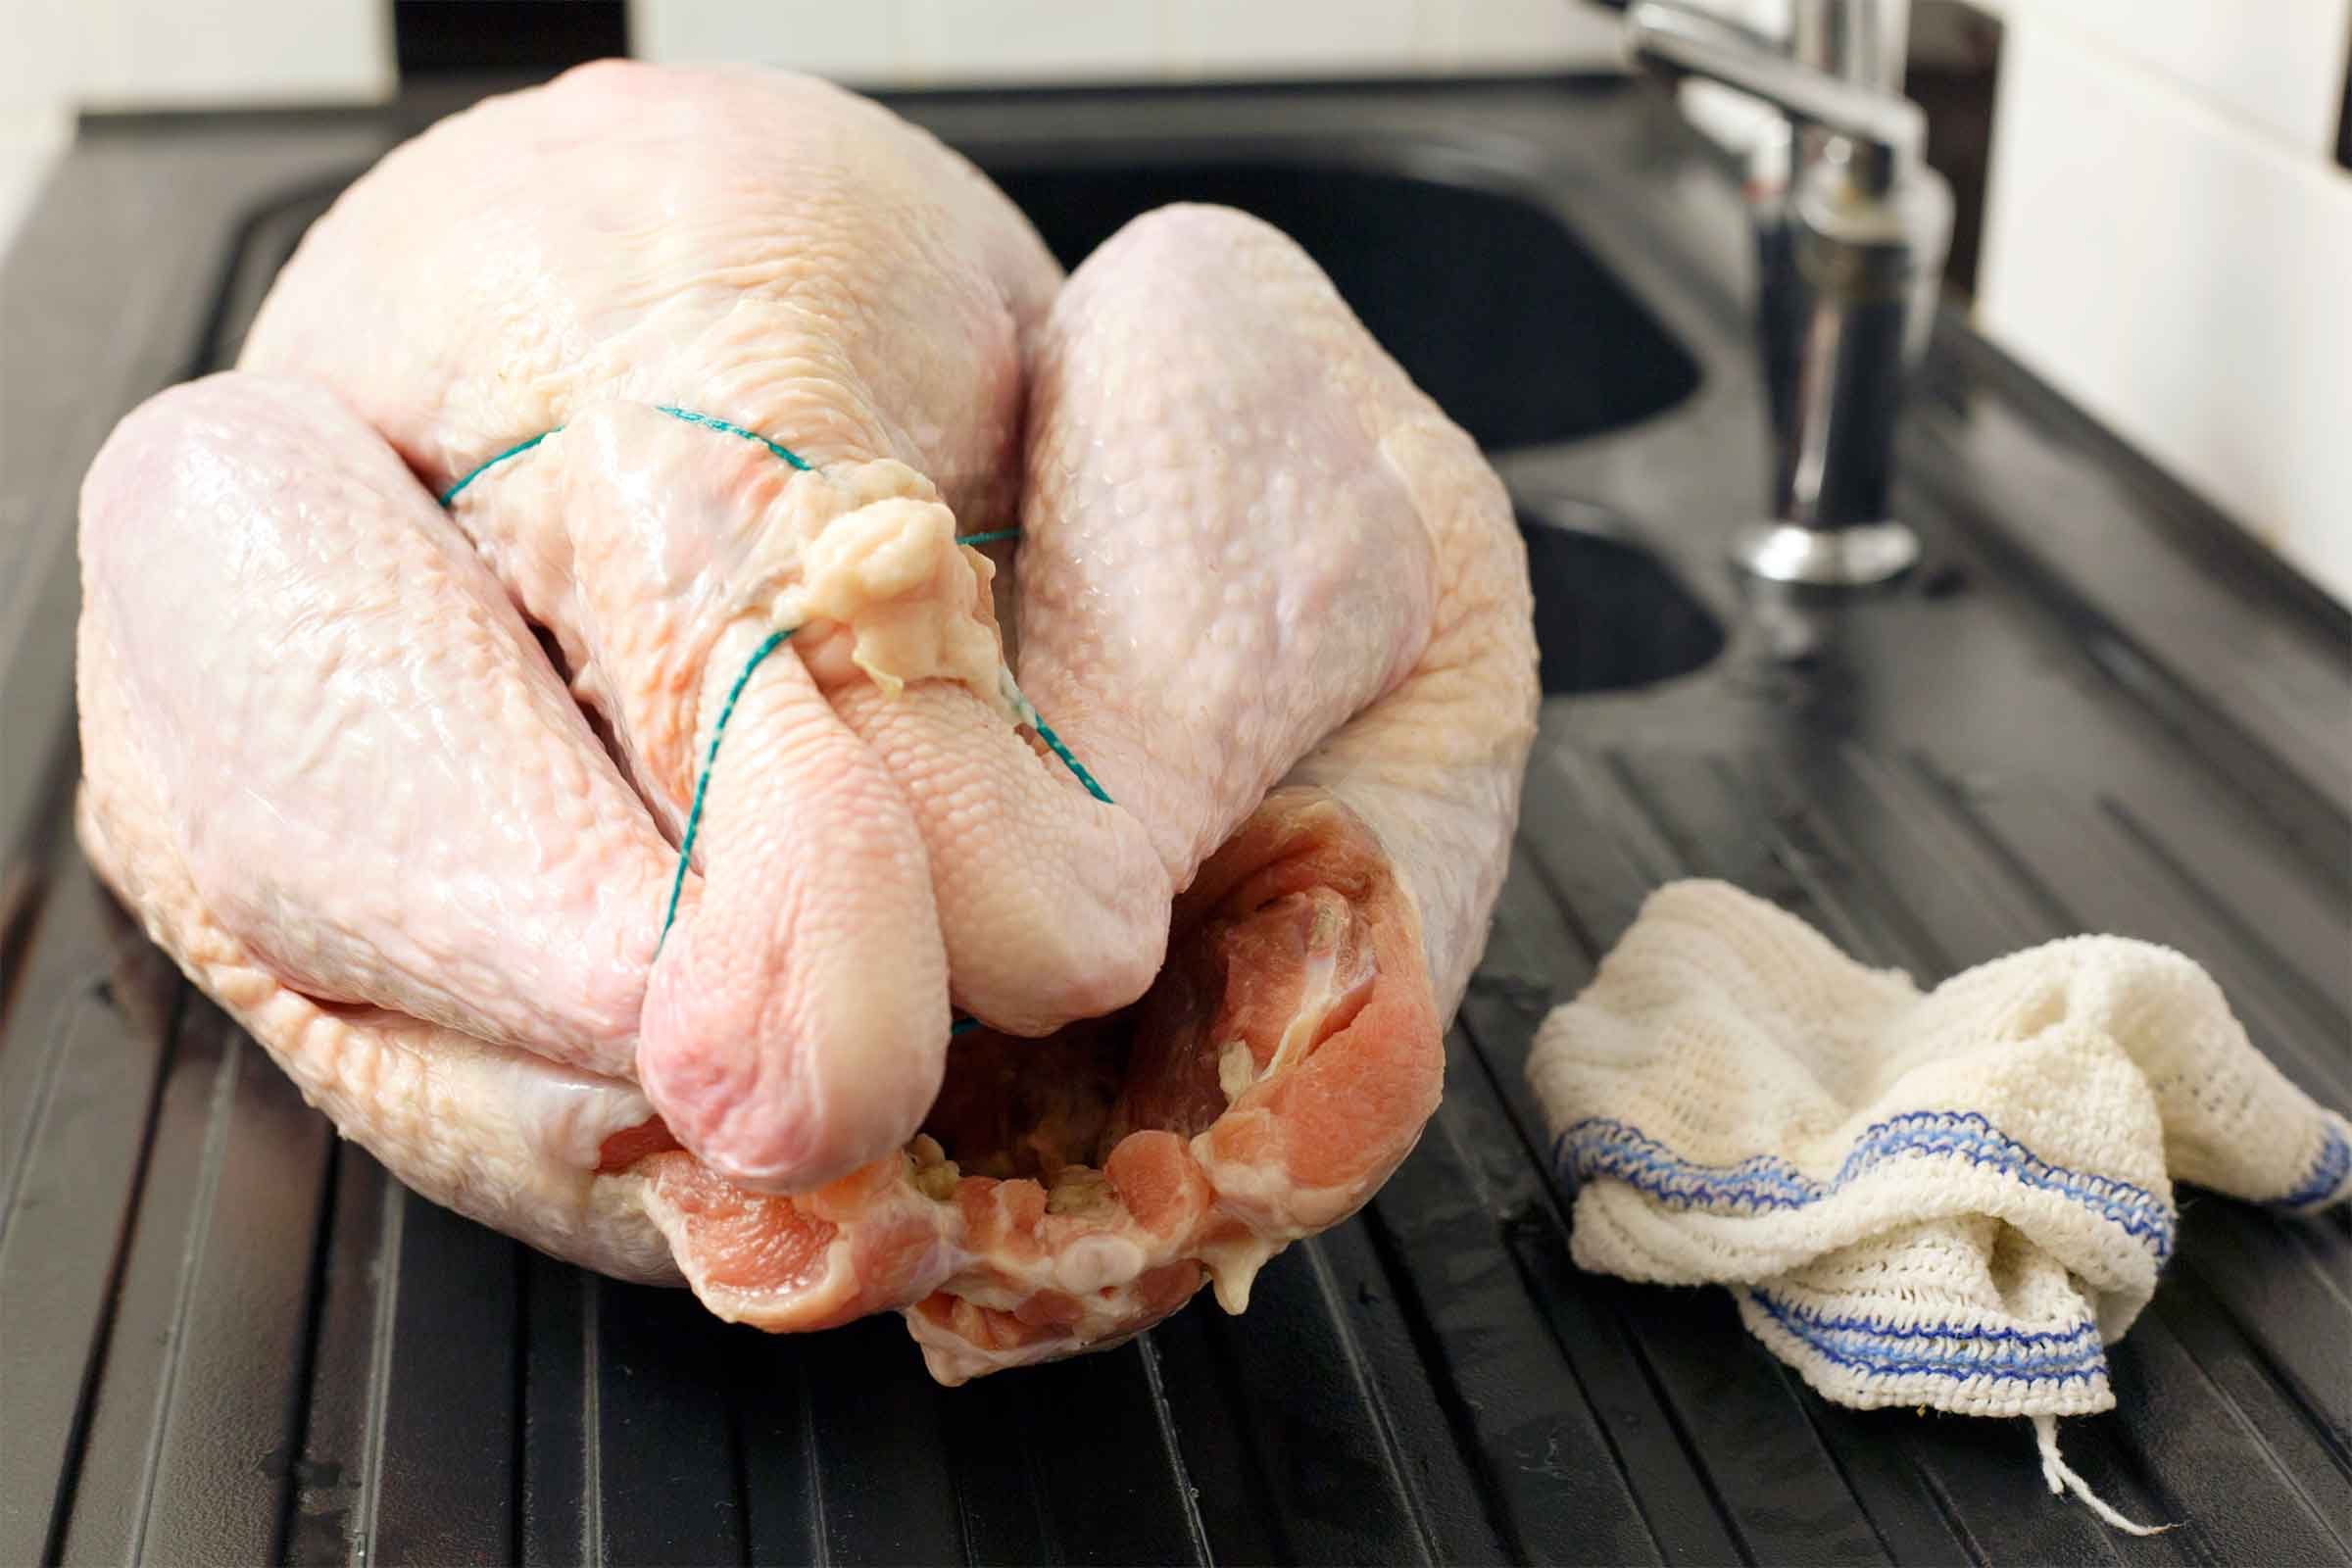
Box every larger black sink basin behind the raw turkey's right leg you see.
[988,163,1698,452]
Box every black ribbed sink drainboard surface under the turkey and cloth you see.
[0,82,2352,1563]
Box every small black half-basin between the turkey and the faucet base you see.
[1519,508,1724,696]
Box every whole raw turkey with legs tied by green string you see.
[80,66,1536,1380]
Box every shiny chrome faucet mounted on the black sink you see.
[1625,0,1952,588]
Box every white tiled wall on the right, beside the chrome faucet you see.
[1978,0,2352,602]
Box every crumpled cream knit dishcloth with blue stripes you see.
[1529,882,2352,1531]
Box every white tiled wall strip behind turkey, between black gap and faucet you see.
[630,0,1616,84]
